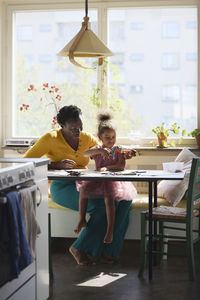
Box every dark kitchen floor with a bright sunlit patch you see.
[49,238,200,300]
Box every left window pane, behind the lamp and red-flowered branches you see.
[12,9,97,137]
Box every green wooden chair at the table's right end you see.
[138,158,200,280]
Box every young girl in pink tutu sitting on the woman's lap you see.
[74,113,137,243]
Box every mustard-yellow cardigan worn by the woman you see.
[24,129,98,169]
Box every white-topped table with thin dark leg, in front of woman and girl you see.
[48,169,185,280]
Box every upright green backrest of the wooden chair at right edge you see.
[187,158,200,221]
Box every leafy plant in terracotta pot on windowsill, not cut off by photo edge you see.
[152,122,186,148]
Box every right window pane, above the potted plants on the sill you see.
[108,7,197,137]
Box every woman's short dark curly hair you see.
[57,105,82,126]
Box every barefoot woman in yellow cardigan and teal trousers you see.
[24,105,132,265]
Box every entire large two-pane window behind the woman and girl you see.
[7,0,200,137]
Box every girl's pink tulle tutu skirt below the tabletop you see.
[76,181,137,201]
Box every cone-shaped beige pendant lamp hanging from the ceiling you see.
[57,0,114,69]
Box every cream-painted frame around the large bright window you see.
[0,0,200,145]
